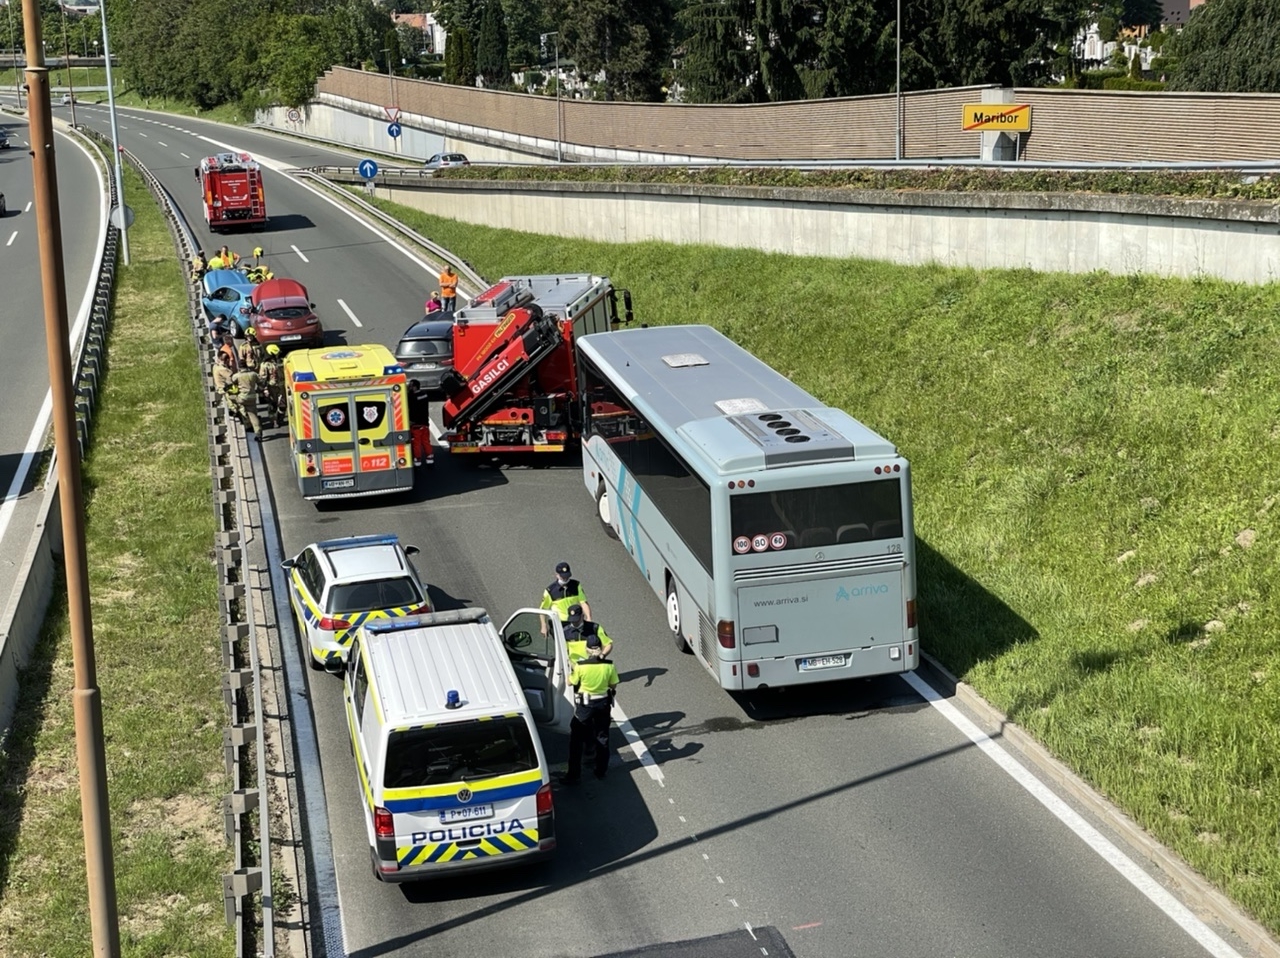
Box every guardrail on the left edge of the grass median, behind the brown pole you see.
[0,115,120,731]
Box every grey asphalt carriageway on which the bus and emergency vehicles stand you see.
[64,108,1247,958]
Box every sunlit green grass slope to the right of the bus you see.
[360,194,1280,932]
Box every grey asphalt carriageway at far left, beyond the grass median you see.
[0,114,101,545]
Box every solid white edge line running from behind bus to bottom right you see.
[902,672,1240,958]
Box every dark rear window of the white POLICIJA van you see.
[383,717,538,789]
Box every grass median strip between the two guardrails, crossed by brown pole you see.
[0,168,232,958]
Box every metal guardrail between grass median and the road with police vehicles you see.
[85,133,275,958]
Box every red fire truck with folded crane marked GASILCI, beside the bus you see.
[443,274,631,455]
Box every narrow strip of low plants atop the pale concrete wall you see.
[436,165,1280,202]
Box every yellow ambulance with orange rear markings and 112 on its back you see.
[284,345,413,499]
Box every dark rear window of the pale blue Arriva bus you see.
[730,478,902,553]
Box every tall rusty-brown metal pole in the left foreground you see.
[22,0,120,958]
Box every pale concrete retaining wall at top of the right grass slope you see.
[358,181,1280,283]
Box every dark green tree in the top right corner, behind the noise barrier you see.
[1166,0,1280,93]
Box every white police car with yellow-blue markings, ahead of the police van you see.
[282,535,431,671]
